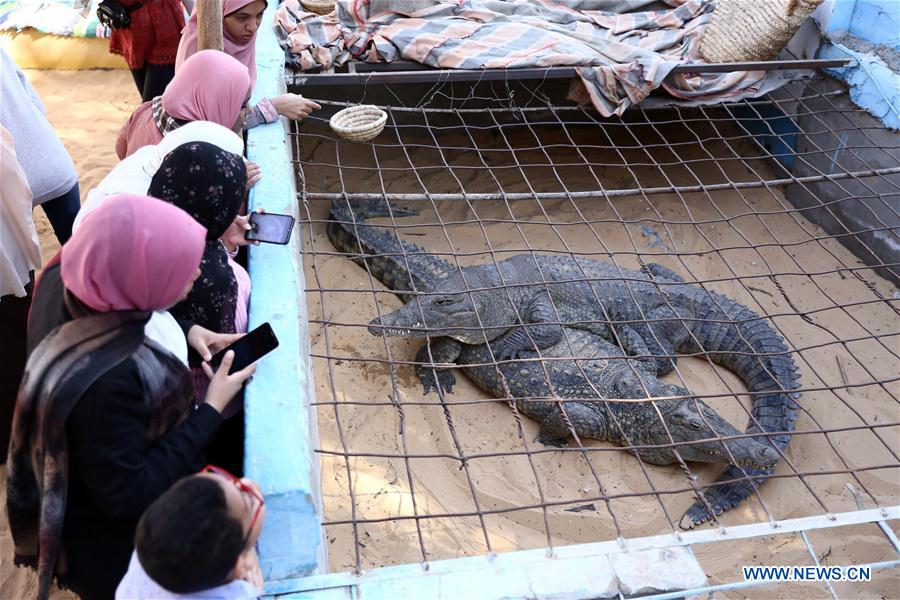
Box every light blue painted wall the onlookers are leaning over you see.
[245,2,326,581]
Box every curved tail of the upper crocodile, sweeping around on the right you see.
[679,288,800,527]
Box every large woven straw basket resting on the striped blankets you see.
[700,0,822,63]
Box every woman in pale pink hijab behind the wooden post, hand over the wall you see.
[175,0,321,129]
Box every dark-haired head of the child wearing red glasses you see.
[135,467,265,594]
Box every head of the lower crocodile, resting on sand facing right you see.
[616,375,779,469]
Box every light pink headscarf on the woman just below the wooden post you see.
[162,50,250,129]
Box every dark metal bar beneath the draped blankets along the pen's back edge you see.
[290,59,852,86]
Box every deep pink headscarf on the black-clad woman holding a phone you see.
[60,194,206,312]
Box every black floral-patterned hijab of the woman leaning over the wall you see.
[147,142,247,333]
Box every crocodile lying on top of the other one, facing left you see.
[369,204,800,528]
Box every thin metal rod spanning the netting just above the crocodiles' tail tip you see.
[306,167,900,202]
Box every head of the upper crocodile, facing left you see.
[369,271,516,344]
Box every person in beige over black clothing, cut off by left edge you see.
[0,125,41,462]
